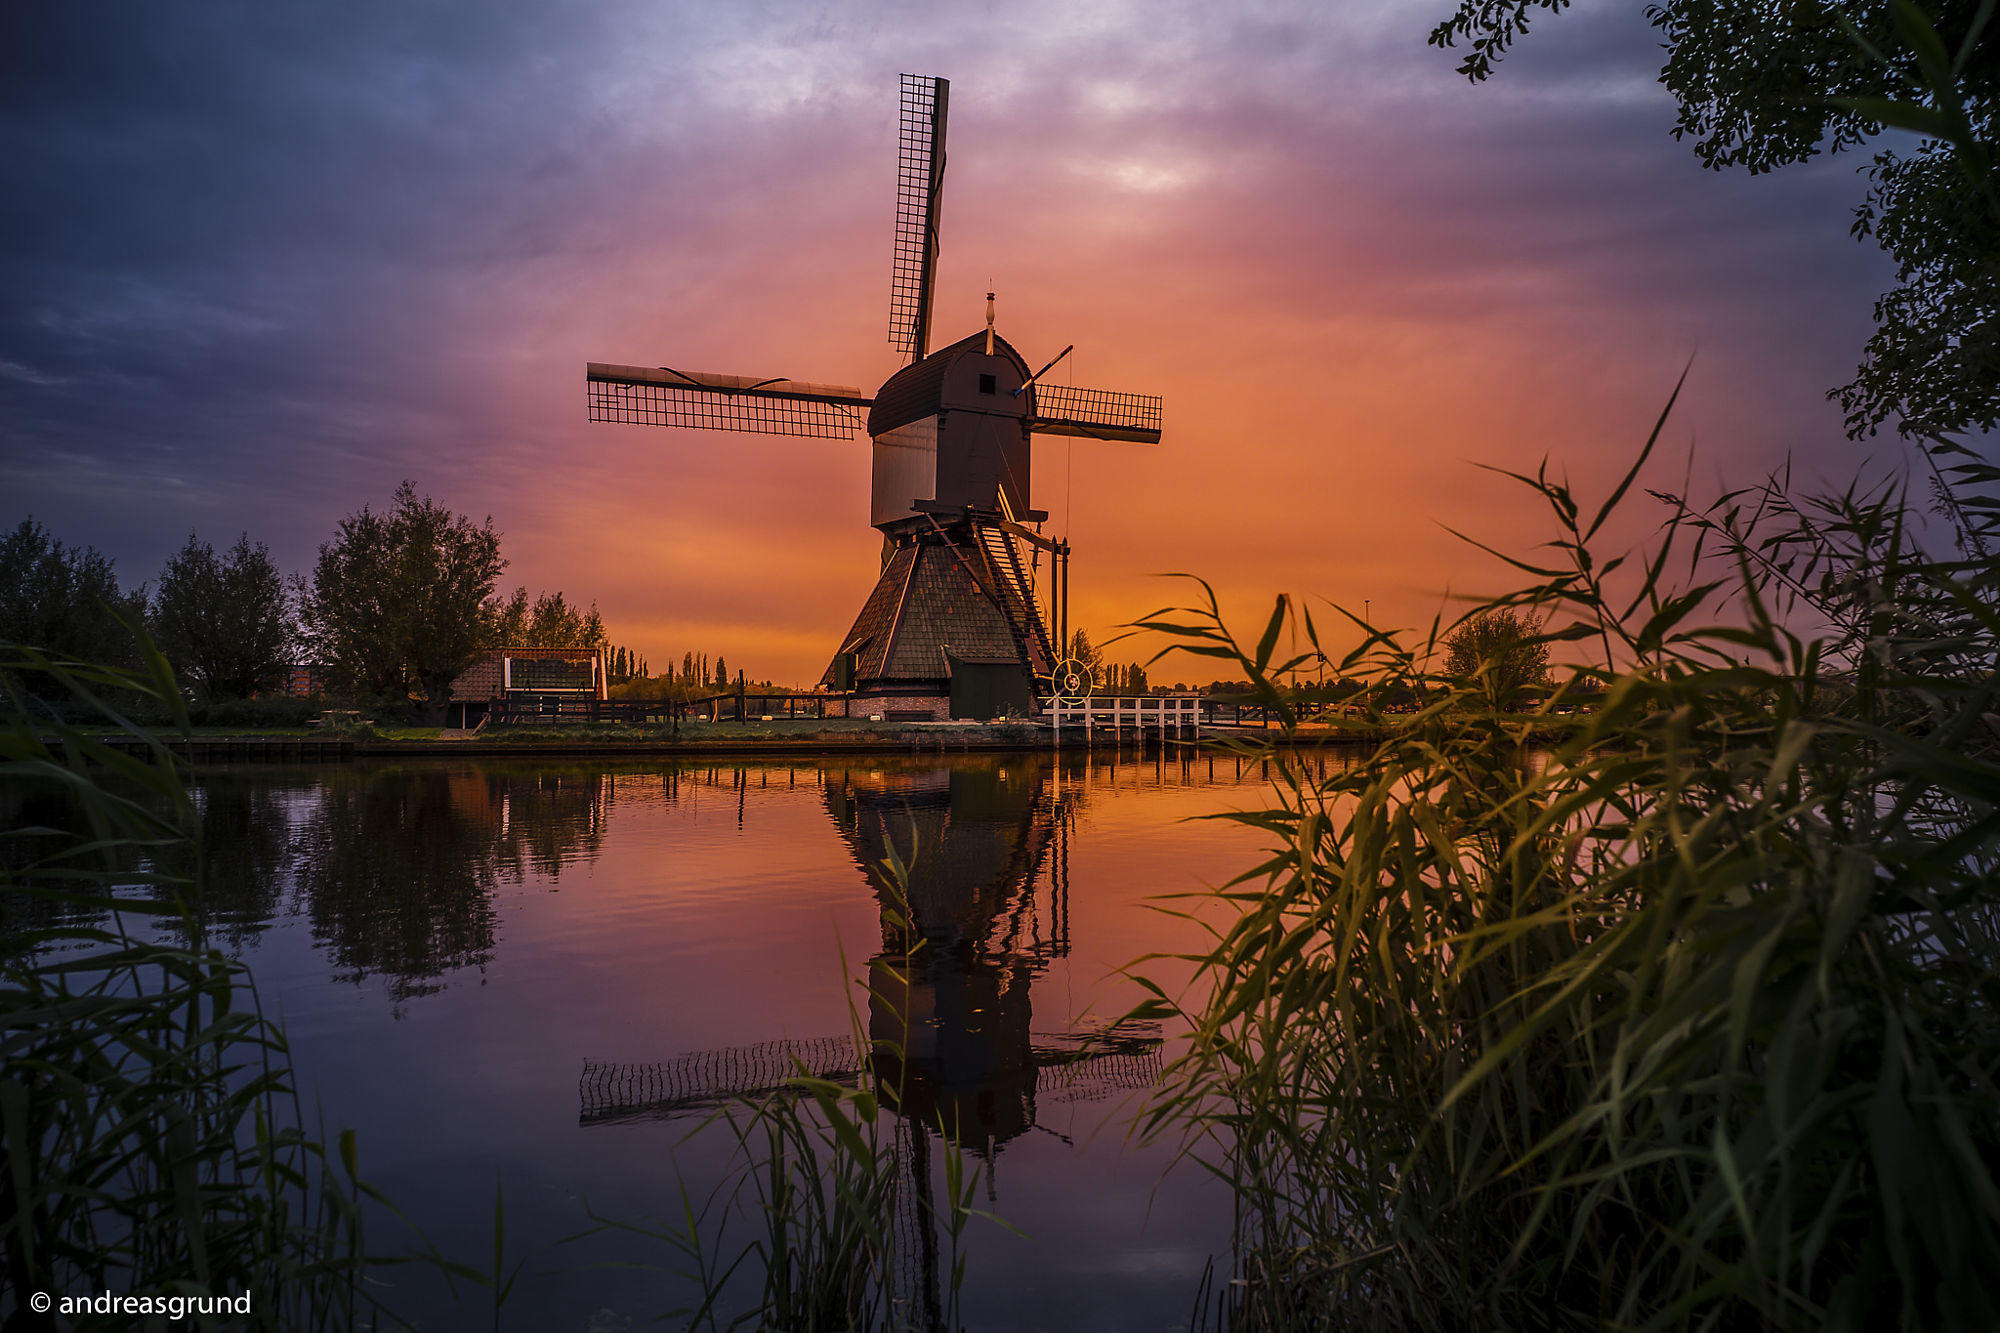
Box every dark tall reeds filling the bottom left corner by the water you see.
[0,642,394,1329]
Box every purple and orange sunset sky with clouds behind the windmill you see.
[0,0,1900,683]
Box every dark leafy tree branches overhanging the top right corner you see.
[1430,0,2000,436]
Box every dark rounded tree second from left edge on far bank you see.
[152,532,294,699]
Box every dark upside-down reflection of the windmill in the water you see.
[580,757,1160,1155]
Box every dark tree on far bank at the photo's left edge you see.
[0,518,146,667]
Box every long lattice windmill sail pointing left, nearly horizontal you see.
[584,360,872,440]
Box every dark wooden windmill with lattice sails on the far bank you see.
[586,74,1160,721]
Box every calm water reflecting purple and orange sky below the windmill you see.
[184,753,1266,1331]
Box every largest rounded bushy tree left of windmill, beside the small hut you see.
[300,482,506,719]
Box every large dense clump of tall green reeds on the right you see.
[1142,416,2000,1331]
